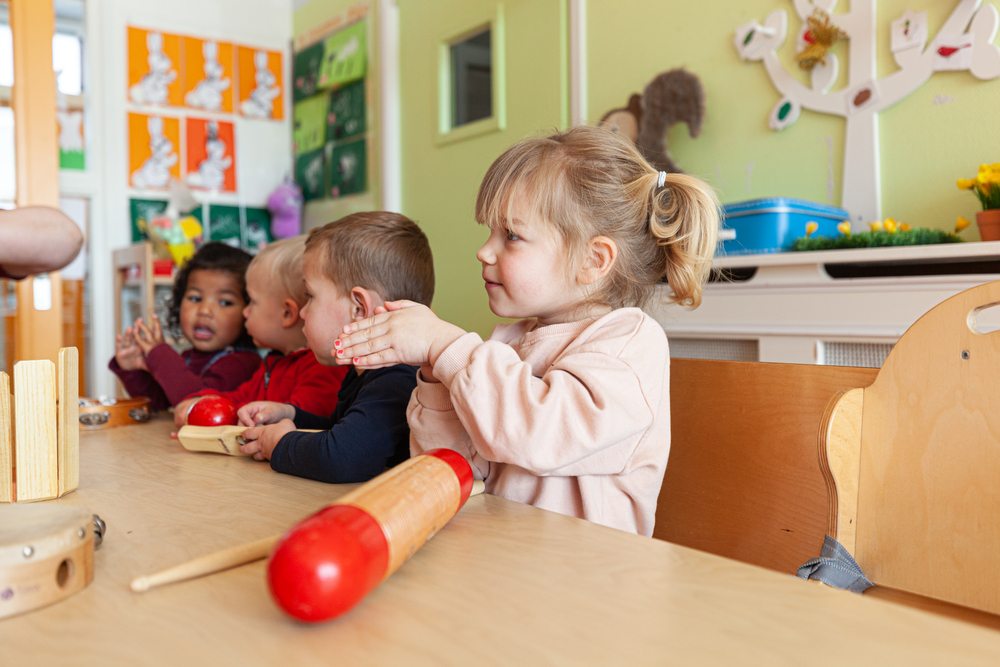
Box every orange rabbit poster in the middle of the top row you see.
[182,37,233,113]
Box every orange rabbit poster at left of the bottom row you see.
[128,113,181,190]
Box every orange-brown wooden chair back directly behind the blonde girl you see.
[653,359,878,574]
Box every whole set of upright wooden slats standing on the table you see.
[0,347,80,503]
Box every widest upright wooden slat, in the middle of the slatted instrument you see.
[14,359,59,502]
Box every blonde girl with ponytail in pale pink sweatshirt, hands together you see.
[334,127,719,535]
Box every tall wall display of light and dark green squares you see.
[292,19,369,201]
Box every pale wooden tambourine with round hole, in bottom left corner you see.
[0,505,105,618]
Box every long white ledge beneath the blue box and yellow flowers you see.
[712,241,1000,269]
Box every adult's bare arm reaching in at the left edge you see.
[0,206,83,278]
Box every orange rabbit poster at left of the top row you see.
[128,27,184,106]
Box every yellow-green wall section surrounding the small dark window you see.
[398,0,567,336]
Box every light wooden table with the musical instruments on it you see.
[0,420,1000,666]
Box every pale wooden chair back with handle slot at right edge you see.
[820,282,1000,614]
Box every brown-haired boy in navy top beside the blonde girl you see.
[239,211,434,484]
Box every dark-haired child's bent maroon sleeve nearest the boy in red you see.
[146,343,260,405]
